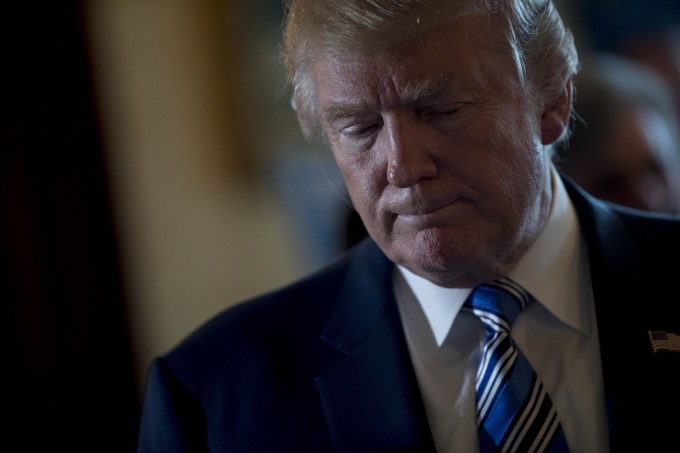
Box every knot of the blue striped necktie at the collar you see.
[464,278,531,333]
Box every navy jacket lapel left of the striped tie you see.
[316,241,434,452]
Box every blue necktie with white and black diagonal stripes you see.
[463,278,569,453]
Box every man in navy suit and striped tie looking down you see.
[139,0,680,452]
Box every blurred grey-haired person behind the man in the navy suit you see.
[555,52,680,214]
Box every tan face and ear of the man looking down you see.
[313,17,571,287]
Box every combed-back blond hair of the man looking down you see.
[281,0,579,141]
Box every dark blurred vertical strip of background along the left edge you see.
[0,1,138,451]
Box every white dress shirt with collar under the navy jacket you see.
[394,169,609,453]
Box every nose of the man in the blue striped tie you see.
[378,114,437,188]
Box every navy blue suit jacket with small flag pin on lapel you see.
[139,177,680,453]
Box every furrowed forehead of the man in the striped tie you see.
[312,16,517,109]
